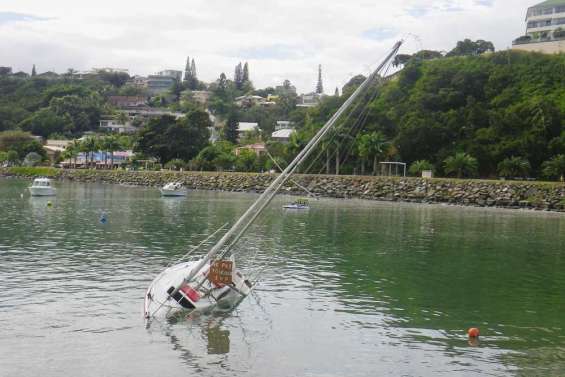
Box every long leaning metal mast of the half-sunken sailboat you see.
[173,41,403,284]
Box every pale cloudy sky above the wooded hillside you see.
[0,0,541,94]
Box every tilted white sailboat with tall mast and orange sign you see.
[144,41,402,320]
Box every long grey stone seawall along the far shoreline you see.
[0,168,565,212]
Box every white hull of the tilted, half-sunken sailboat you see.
[144,261,251,319]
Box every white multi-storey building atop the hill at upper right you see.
[512,0,565,54]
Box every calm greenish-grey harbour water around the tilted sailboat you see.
[0,180,565,377]
